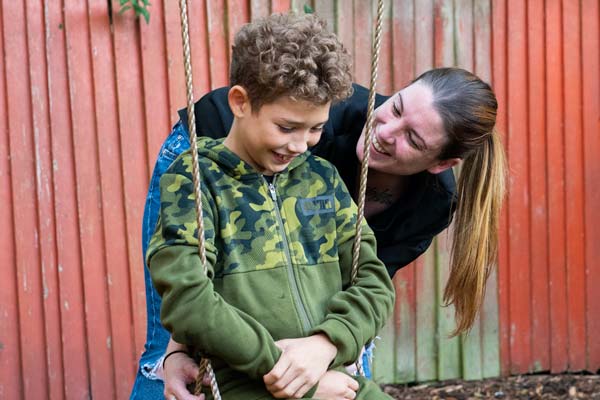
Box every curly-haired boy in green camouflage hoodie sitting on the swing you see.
[147,15,394,400]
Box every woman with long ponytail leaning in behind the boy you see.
[132,68,506,399]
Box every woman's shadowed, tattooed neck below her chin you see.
[365,170,410,217]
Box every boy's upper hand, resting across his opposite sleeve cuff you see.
[263,333,337,398]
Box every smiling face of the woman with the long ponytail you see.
[356,82,458,175]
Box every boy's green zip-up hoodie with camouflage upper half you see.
[146,138,394,396]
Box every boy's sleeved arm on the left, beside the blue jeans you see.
[147,154,281,379]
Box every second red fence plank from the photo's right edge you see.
[562,0,586,371]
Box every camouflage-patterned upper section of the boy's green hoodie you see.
[148,138,358,277]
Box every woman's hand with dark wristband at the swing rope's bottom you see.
[163,339,210,400]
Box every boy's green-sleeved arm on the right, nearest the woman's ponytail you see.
[311,169,395,368]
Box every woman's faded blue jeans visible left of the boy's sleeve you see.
[130,122,190,400]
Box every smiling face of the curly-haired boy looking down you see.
[224,86,330,175]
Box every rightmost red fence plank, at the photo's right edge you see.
[581,0,600,371]
